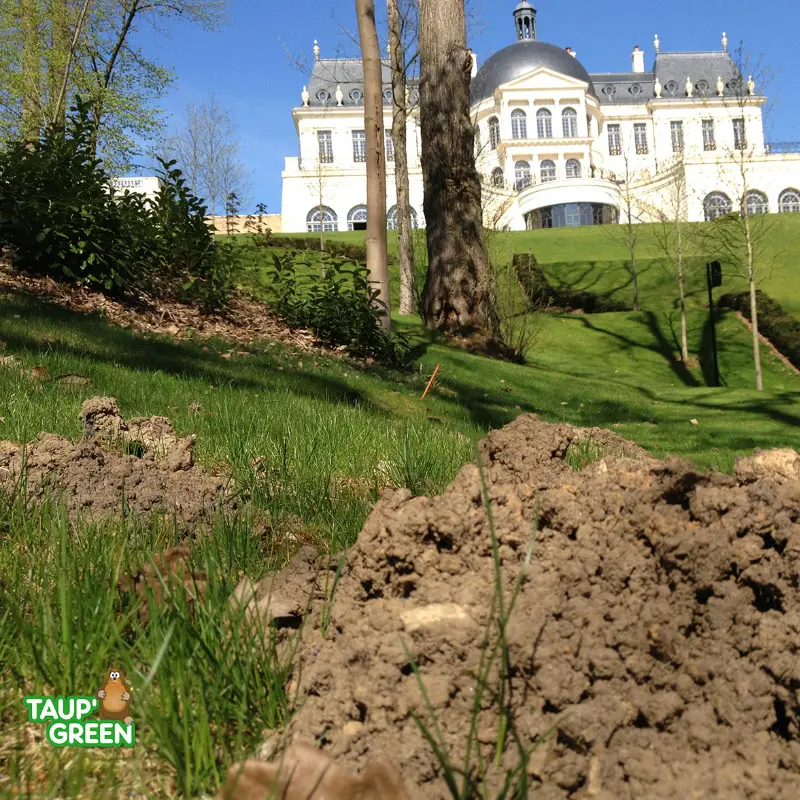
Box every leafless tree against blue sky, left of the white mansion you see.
[170,93,247,218]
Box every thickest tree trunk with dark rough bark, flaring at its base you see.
[419,0,499,338]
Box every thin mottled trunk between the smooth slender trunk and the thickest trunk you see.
[387,0,416,314]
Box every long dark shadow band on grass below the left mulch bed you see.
[0,295,380,411]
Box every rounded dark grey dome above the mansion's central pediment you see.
[470,39,596,103]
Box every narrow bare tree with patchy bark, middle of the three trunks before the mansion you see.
[387,0,418,314]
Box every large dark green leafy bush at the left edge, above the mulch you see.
[0,100,234,309]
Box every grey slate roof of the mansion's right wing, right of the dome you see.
[591,50,738,105]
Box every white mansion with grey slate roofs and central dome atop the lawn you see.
[281,0,800,232]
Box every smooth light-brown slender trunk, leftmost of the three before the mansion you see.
[356,0,392,331]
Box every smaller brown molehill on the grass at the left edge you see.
[0,397,225,523]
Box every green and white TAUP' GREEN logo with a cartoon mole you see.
[22,667,136,747]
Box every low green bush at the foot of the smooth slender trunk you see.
[266,251,411,367]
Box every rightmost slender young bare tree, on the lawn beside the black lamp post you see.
[704,44,775,391]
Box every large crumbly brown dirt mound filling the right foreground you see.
[270,416,800,800]
